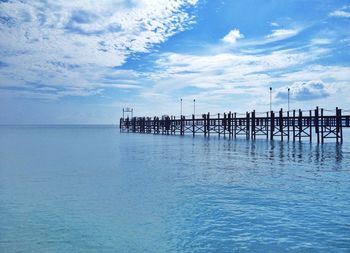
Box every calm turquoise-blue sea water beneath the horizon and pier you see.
[0,126,350,253]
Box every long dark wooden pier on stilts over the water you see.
[119,107,350,143]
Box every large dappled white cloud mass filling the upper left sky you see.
[0,0,197,95]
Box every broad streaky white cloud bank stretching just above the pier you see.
[135,44,350,112]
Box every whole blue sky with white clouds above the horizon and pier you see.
[0,0,350,124]
